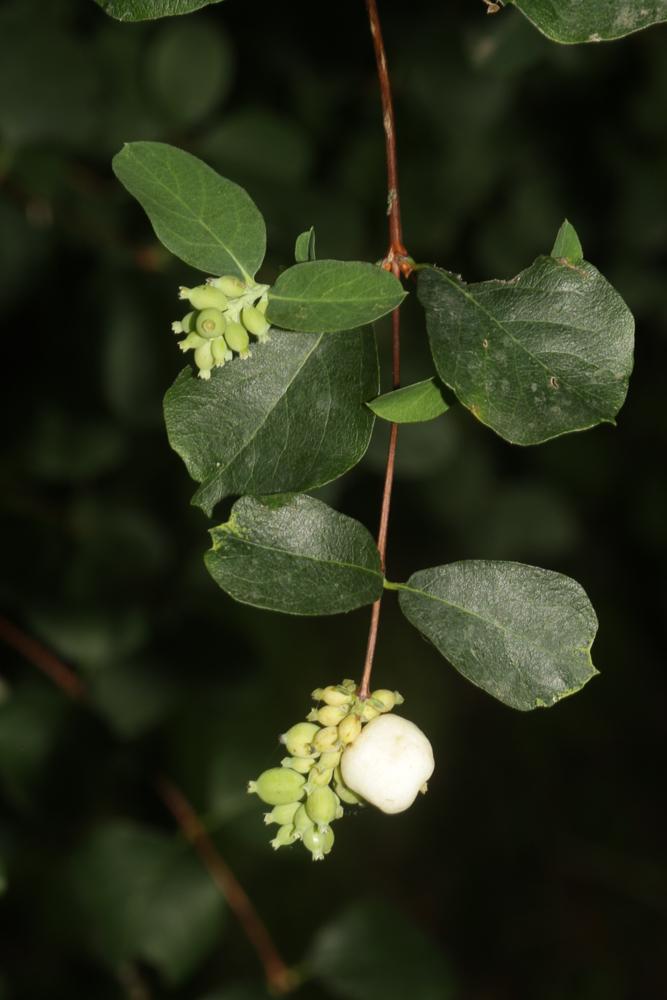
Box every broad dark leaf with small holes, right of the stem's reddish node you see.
[419,237,634,445]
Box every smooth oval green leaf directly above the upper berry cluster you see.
[113,142,266,278]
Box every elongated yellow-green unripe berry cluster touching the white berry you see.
[248,680,403,861]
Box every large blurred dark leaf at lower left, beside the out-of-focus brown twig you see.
[67,821,223,985]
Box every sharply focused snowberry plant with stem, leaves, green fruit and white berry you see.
[98,0,667,859]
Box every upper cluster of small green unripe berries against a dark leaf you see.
[171,274,270,379]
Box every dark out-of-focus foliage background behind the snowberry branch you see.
[0,0,667,1000]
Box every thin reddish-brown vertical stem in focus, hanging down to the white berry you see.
[359,0,404,698]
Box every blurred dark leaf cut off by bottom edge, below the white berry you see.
[306,900,455,1000]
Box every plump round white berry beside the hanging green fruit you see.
[340,715,435,813]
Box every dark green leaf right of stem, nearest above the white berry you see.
[396,560,597,711]
